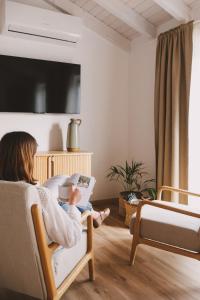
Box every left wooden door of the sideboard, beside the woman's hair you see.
[33,155,51,184]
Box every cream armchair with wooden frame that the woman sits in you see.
[0,181,94,300]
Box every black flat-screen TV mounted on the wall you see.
[0,55,81,114]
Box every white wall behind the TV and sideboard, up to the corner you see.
[0,5,129,199]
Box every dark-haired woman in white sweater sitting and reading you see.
[0,131,109,248]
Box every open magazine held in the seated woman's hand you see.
[43,173,96,206]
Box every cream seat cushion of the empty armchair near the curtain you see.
[130,200,200,252]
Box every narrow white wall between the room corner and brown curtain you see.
[129,39,156,178]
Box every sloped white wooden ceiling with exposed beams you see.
[10,0,200,49]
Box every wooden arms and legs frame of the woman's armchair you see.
[31,204,94,299]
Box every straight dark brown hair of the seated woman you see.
[0,131,37,184]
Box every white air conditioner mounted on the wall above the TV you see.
[1,0,82,44]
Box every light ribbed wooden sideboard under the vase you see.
[34,151,92,184]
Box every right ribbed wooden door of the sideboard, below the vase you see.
[52,153,91,176]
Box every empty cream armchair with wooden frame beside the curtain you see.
[130,186,200,264]
